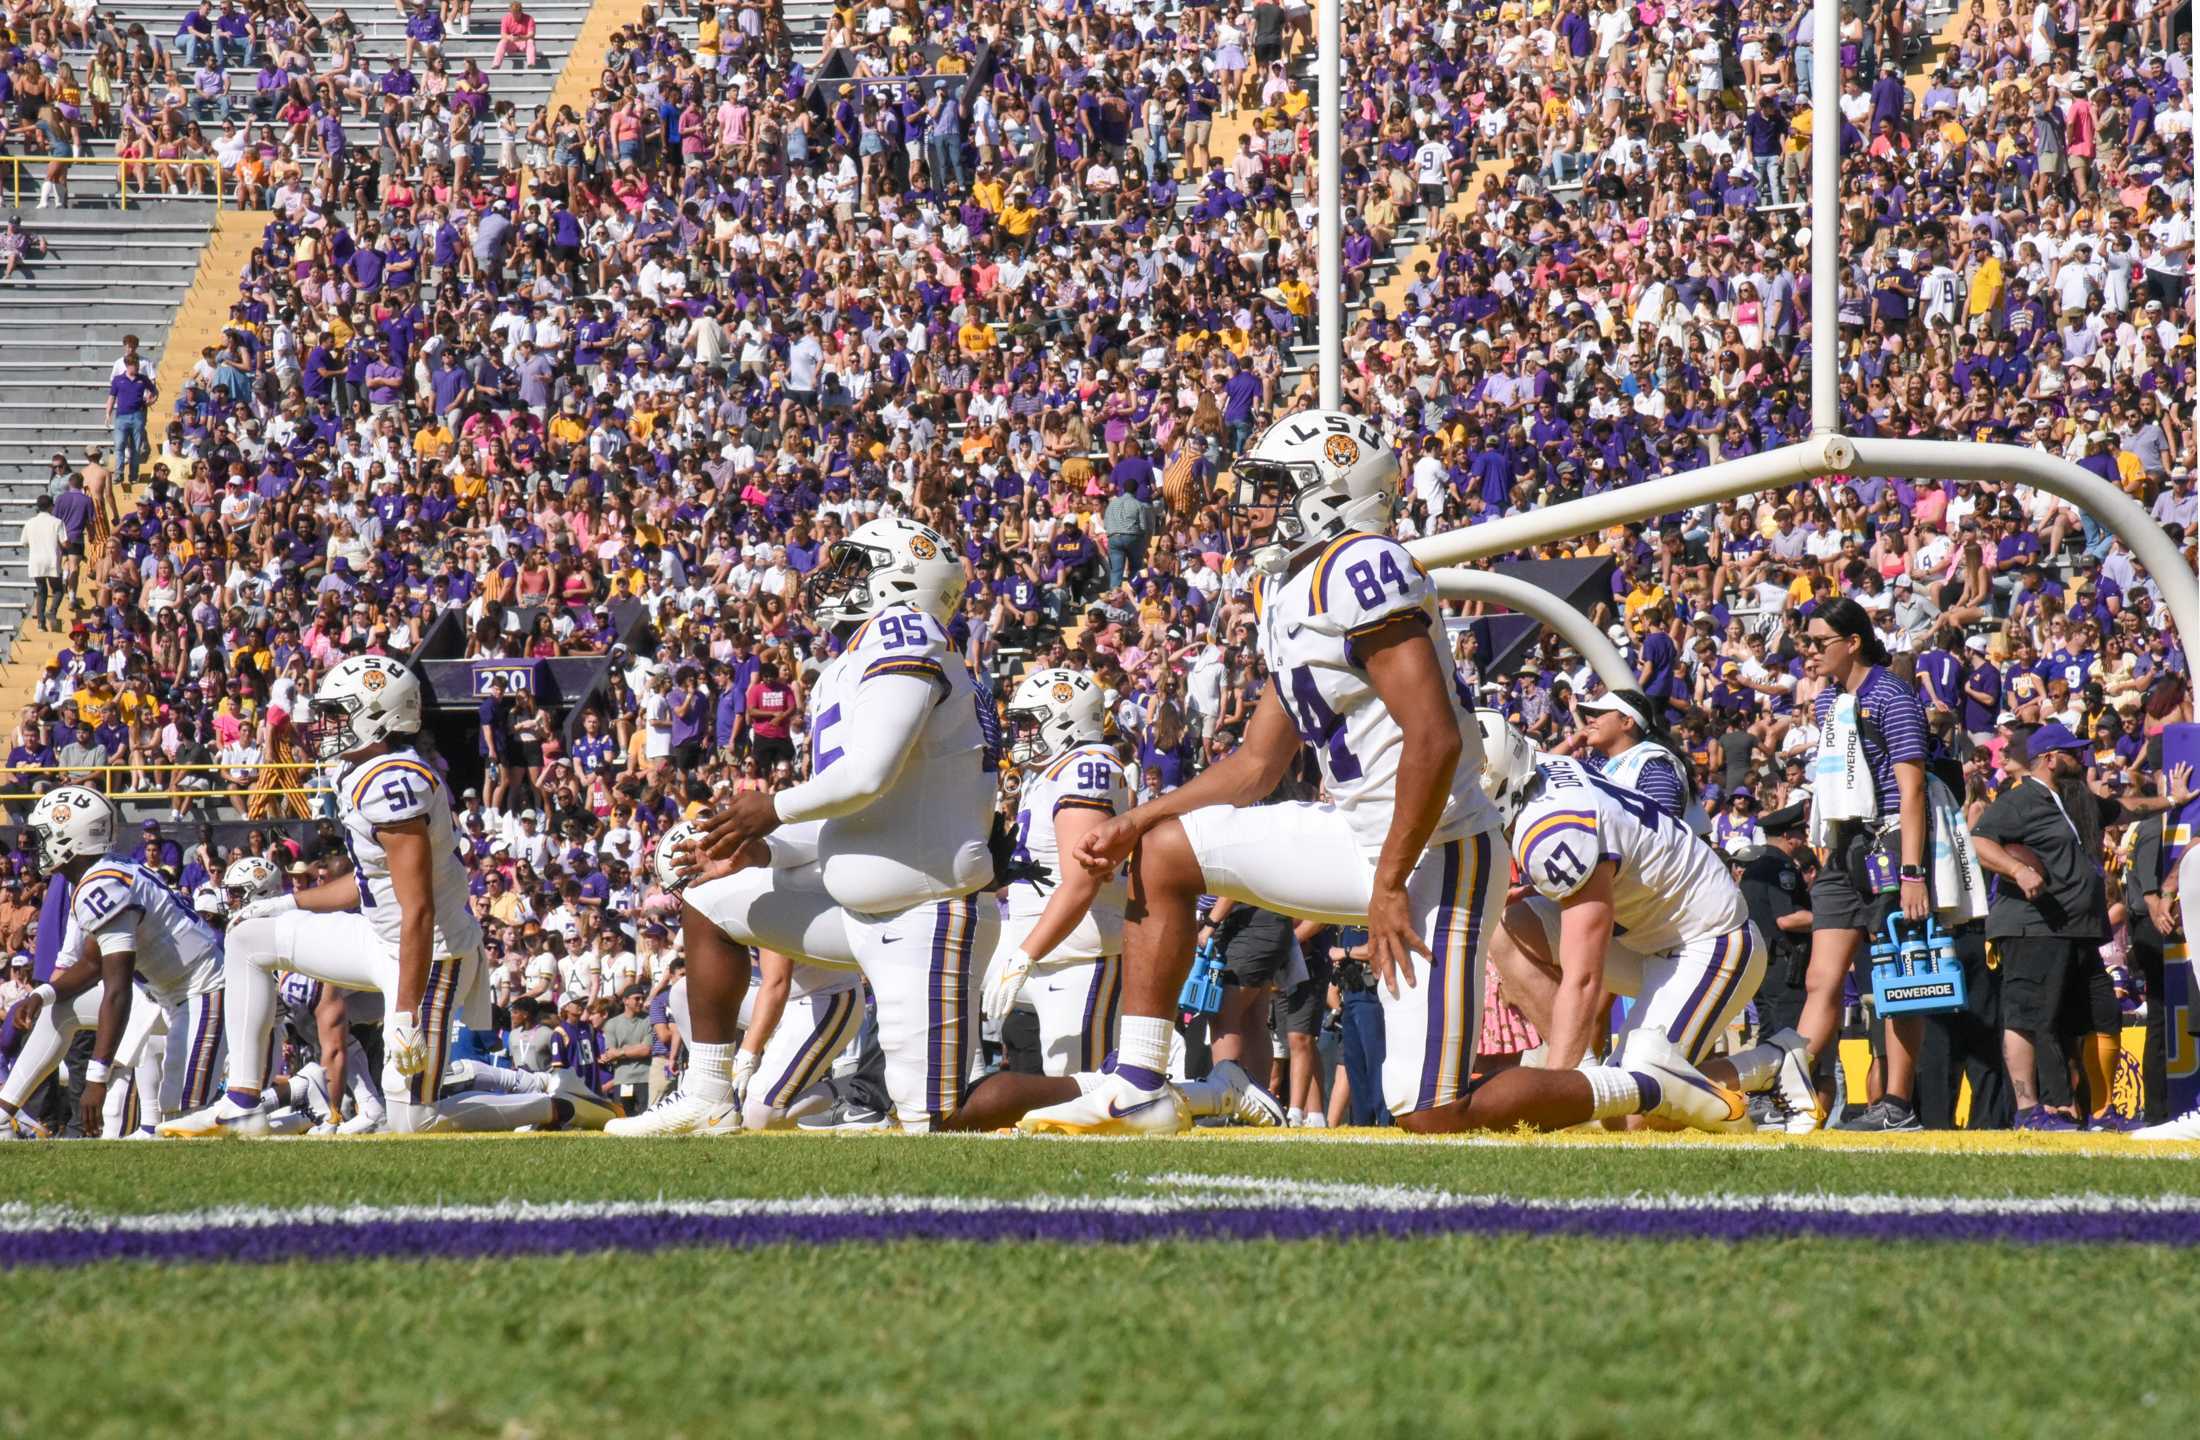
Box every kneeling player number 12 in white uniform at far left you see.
[0,785,222,1139]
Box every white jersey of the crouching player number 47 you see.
[1514,758,1749,954]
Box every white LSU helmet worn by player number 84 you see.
[1230,411,1399,569]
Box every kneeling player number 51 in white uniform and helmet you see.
[161,655,614,1139]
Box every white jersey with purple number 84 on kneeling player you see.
[1254,534,1498,851]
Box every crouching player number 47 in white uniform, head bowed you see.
[1478,710,1819,1128]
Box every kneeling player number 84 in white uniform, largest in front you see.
[1021,411,1740,1134]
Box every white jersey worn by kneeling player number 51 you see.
[337,750,482,956]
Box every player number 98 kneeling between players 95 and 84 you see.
[961,668,1283,1130]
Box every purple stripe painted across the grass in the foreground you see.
[0,1205,2200,1269]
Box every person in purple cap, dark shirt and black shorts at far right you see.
[1971,721,2191,1130]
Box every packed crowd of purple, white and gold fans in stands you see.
[0,0,2200,1108]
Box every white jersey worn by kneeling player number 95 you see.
[810,605,1001,915]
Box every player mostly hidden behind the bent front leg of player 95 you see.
[629,820,862,1130]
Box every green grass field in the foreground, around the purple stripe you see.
[0,1137,2200,1438]
